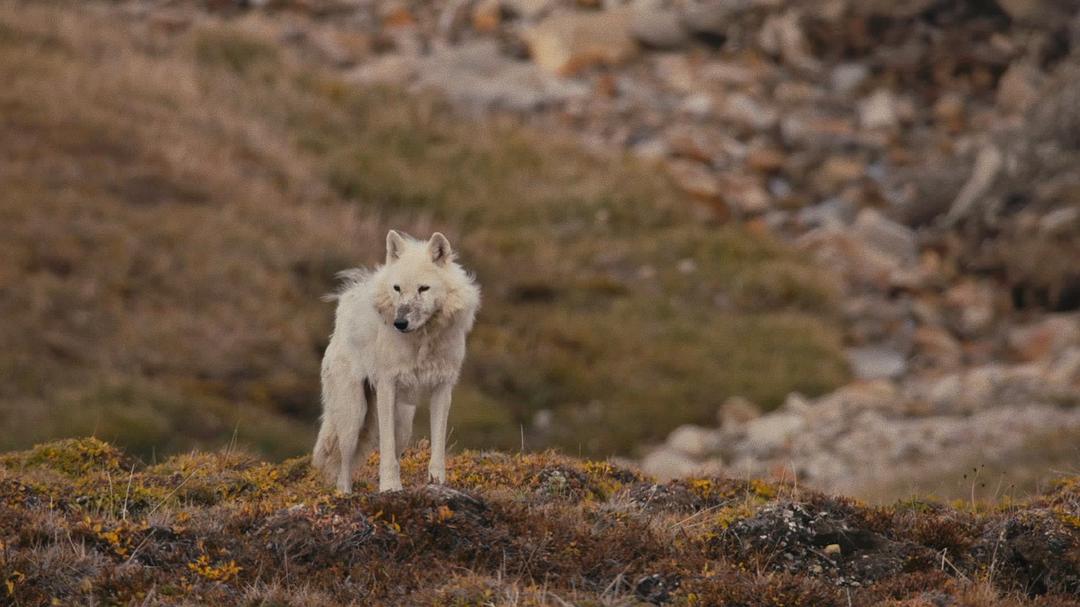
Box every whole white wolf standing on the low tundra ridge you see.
[312,230,480,493]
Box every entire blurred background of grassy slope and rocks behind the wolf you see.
[0,0,1080,500]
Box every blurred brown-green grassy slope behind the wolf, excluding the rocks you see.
[0,0,846,459]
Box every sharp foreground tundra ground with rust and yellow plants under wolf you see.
[0,440,1080,607]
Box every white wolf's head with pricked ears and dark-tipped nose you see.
[375,230,460,333]
